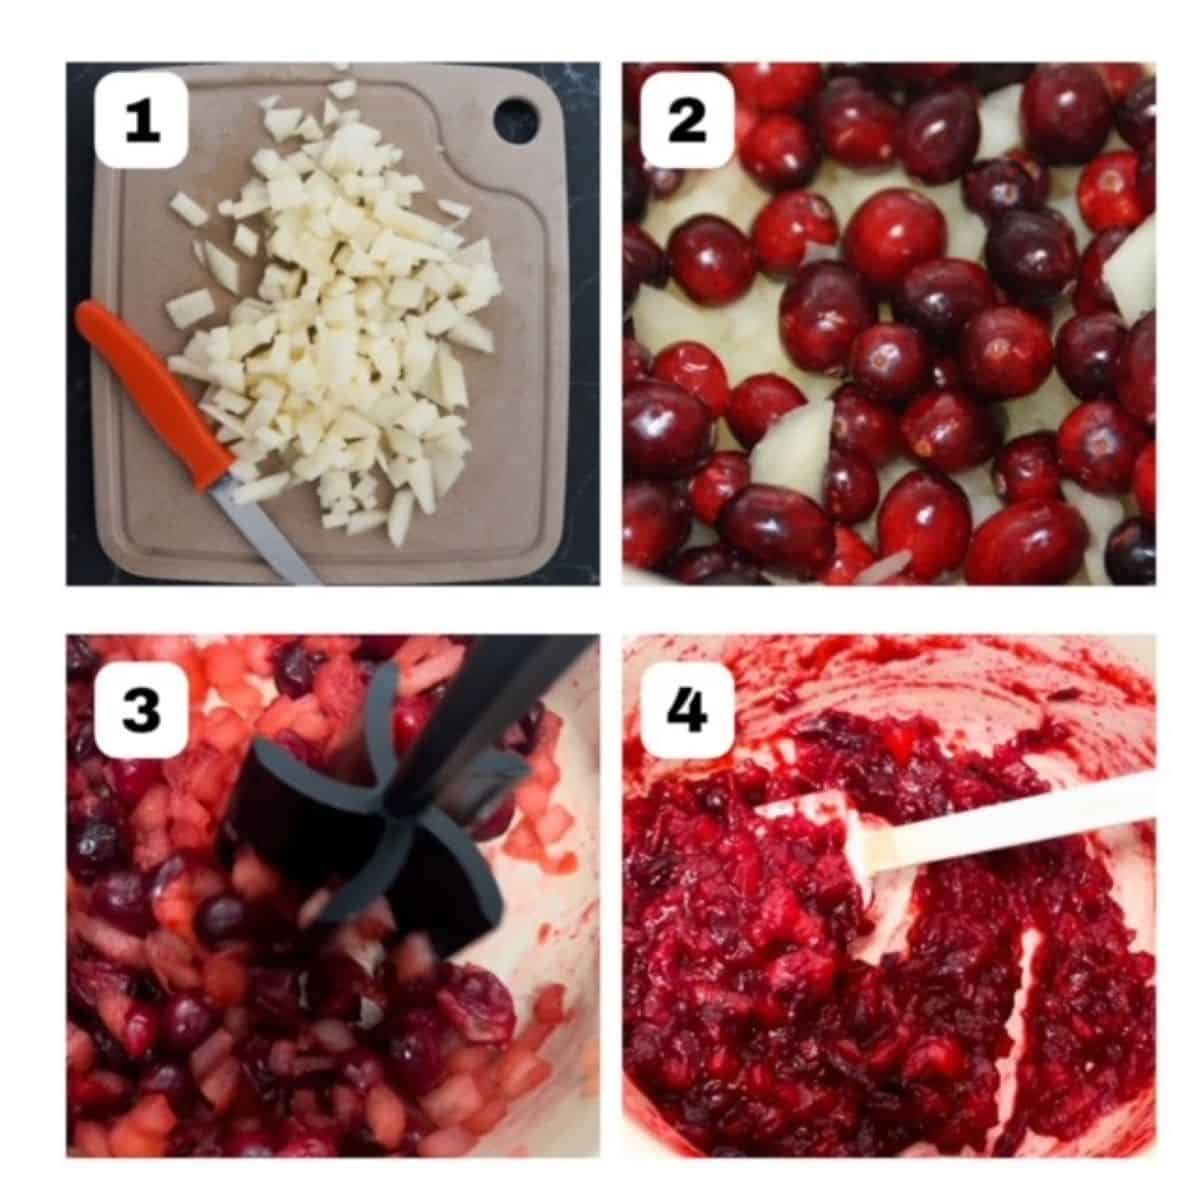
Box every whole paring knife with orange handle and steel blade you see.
[74,300,320,586]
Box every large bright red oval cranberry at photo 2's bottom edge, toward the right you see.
[962,500,1088,587]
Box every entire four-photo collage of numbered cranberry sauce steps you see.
[64,60,1158,1163]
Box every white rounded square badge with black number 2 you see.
[641,71,733,169]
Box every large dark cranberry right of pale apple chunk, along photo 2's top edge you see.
[1021,62,1112,167]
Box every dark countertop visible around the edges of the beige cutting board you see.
[64,62,600,586]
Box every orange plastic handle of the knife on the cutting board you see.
[76,300,234,492]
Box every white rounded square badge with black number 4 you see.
[641,662,736,758]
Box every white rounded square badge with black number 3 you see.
[92,662,188,758]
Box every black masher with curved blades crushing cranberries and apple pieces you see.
[223,636,594,955]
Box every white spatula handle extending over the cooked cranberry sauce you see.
[863,770,1154,875]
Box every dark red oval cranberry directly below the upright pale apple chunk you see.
[720,484,834,580]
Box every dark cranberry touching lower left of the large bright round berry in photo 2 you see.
[779,262,878,374]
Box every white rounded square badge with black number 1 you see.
[92,71,188,170]
